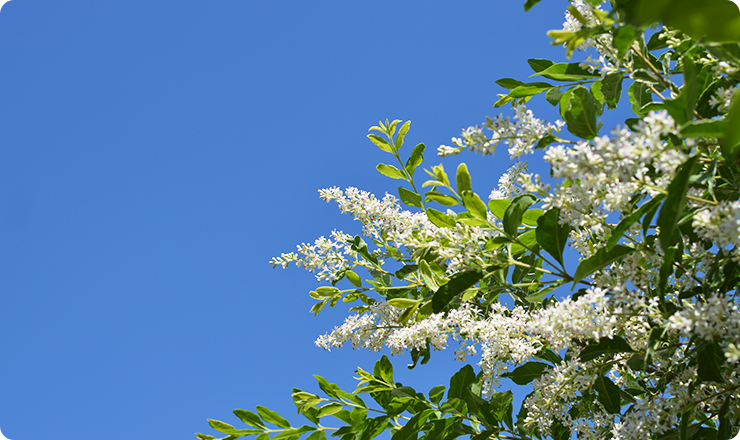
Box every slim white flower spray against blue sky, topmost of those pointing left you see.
[437,105,565,158]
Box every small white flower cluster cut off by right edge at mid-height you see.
[692,201,740,261]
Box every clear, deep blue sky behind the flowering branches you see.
[0,0,588,440]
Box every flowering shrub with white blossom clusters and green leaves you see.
[197,0,740,440]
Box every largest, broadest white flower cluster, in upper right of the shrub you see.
[522,111,687,234]
